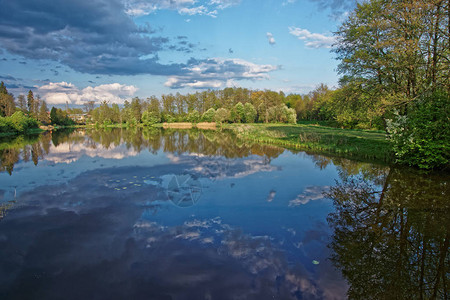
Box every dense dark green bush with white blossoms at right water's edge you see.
[386,91,450,169]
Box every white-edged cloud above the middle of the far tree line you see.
[165,58,278,88]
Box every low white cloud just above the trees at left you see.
[38,81,138,105]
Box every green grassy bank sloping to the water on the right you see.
[223,124,392,162]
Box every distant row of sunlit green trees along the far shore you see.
[90,88,301,125]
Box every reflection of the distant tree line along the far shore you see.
[0,128,284,174]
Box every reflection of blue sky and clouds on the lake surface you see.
[0,129,347,299]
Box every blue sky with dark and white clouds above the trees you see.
[0,0,354,105]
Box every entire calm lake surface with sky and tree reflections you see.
[0,130,450,299]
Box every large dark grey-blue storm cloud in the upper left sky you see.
[0,0,184,75]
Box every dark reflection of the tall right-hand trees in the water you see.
[327,168,450,299]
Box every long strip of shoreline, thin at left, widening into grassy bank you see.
[0,122,393,163]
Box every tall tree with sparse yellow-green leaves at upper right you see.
[334,0,450,108]
